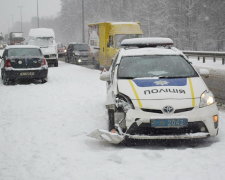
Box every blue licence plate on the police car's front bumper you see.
[151,118,188,128]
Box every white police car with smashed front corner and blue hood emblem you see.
[90,38,218,144]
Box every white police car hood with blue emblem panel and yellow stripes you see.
[118,77,208,100]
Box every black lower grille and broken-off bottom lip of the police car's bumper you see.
[89,122,210,144]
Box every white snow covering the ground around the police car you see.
[0,62,225,180]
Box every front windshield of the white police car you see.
[118,55,198,79]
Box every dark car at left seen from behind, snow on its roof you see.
[1,45,48,85]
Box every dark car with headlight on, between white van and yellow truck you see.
[65,43,93,64]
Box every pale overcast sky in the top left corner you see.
[0,0,60,33]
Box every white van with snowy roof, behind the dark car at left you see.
[28,28,58,67]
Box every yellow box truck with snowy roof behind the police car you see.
[88,22,143,69]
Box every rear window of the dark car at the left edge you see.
[8,48,41,57]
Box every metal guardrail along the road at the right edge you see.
[182,50,225,65]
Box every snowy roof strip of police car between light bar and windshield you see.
[121,47,182,56]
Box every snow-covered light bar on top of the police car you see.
[121,37,173,47]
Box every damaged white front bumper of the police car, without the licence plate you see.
[89,104,218,144]
